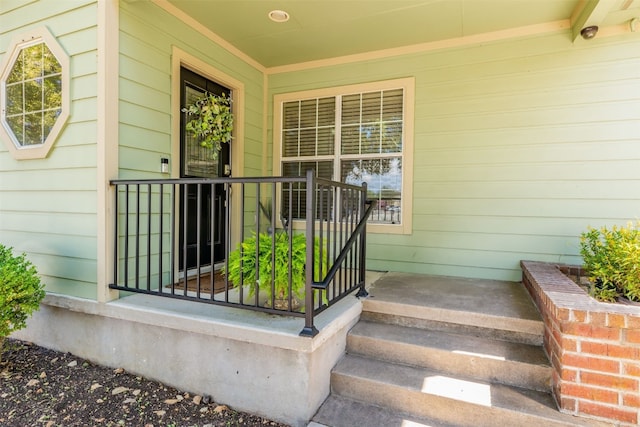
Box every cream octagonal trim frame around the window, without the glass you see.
[0,27,71,159]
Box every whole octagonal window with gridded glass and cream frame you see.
[1,29,69,159]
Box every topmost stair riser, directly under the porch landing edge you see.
[360,311,544,345]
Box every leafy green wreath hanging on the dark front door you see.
[182,93,233,157]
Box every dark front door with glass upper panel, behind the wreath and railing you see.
[180,68,231,270]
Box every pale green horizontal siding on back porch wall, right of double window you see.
[269,34,640,280]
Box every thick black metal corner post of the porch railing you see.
[300,169,318,337]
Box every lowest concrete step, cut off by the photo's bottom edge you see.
[309,395,455,427]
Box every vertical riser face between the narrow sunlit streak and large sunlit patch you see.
[347,334,552,392]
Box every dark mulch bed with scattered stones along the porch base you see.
[0,339,286,427]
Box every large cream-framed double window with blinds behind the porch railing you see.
[274,79,414,233]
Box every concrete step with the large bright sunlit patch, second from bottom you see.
[331,354,604,427]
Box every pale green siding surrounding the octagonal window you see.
[0,0,97,298]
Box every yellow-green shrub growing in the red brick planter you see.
[580,222,640,301]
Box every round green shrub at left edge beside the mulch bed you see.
[0,245,45,358]
